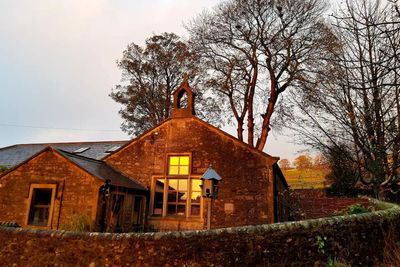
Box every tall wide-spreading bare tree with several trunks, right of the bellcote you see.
[187,0,329,150]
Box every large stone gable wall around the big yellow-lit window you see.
[105,118,276,229]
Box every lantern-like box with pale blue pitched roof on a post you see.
[200,165,222,229]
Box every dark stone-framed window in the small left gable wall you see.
[27,185,56,226]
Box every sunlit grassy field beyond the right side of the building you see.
[282,169,329,189]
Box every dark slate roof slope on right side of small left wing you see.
[56,149,147,191]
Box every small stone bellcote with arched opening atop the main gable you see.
[172,73,195,118]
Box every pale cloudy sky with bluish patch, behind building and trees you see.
[0,0,302,160]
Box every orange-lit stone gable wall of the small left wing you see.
[0,149,103,229]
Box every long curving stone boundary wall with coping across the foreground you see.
[0,201,400,267]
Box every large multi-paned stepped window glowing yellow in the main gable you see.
[152,155,201,217]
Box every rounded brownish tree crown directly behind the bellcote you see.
[110,33,219,135]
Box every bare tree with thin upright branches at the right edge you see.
[292,0,400,197]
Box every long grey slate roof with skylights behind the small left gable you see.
[0,141,128,168]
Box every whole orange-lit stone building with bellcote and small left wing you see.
[0,80,288,231]
